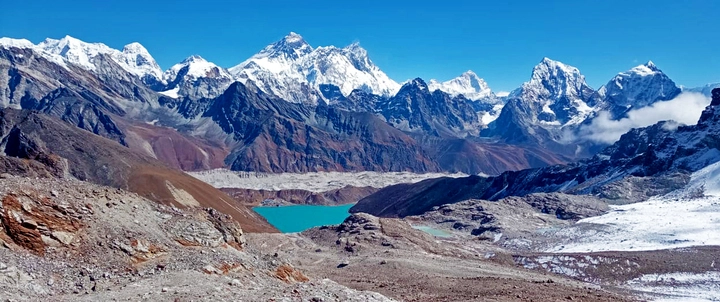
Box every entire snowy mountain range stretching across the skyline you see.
[0,33,714,165]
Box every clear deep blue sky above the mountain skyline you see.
[0,0,720,91]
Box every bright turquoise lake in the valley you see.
[253,204,353,233]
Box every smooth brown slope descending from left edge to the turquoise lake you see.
[0,109,275,232]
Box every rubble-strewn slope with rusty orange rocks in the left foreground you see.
[0,175,391,301]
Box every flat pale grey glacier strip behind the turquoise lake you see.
[188,169,467,192]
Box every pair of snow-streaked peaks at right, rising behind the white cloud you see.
[481,58,682,157]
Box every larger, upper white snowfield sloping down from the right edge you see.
[548,163,720,253]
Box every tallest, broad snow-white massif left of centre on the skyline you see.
[229,33,400,104]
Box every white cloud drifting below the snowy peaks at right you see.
[578,92,710,144]
